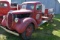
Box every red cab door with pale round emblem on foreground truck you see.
[35,4,42,24]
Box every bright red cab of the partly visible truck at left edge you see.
[0,1,10,24]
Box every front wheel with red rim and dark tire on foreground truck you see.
[21,24,34,40]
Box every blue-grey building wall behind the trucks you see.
[11,0,60,14]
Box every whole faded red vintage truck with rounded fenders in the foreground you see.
[1,1,53,40]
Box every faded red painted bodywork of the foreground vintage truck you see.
[2,2,53,33]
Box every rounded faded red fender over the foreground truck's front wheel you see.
[16,18,38,33]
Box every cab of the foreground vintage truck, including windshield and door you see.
[22,1,42,24]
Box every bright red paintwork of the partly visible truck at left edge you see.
[0,0,20,24]
